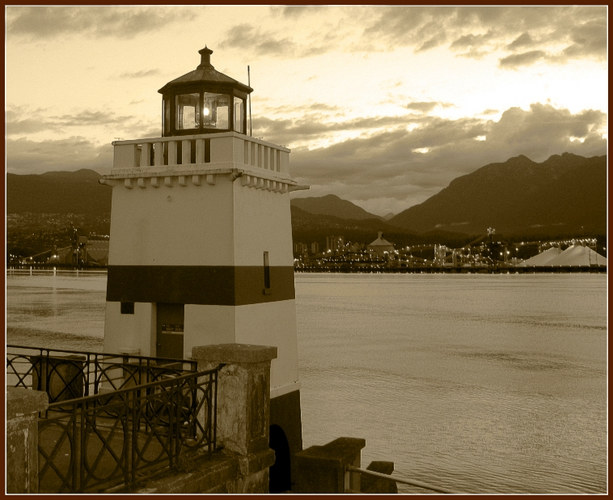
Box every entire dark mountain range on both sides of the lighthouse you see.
[6,153,607,254]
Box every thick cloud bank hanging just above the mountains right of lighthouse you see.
[285,104,607,209]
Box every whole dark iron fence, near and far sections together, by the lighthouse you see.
[7,345,219,493]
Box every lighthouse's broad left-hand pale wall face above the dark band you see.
[109,175,234,266]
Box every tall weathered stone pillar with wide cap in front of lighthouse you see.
[192,344,277,493]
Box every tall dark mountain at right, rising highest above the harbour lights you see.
[389,153,606,234]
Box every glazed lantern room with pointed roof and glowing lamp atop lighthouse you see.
[158,47,253,137]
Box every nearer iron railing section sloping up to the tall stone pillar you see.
[38,369,217,493]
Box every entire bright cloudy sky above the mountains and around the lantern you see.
[5,5,608,215]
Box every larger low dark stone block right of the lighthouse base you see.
[296,437,366,493]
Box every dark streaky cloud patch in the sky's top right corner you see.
[364,6,607,68]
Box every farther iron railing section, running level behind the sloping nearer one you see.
[6,345,197,403]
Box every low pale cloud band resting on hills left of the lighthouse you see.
[6,137,113,174]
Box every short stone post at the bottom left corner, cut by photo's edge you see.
[6,387,49,493]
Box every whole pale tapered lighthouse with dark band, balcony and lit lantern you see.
[101,47,302,490]
